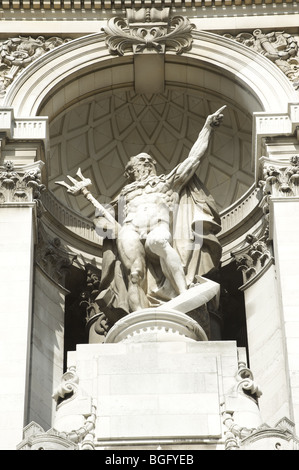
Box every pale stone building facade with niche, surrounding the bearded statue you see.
[0,0,299,450]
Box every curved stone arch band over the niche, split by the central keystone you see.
[3,31,297,117]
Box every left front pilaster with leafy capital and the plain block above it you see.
[0,108,47,450]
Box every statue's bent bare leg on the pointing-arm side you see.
[145,224,187,294]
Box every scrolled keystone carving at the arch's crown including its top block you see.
[102,8,195,55]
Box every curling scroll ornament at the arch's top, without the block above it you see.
[102,16,194,56]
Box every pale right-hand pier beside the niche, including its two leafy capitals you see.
[238,153,299,429]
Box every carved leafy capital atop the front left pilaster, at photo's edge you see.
[0,161,45,203]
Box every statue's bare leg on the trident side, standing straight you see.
[117,226,149,312]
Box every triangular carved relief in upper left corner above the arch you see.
[0,36,71,97]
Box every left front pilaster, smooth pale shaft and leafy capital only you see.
[0,157,43,449]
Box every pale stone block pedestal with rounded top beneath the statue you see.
[54,309,261,450]
